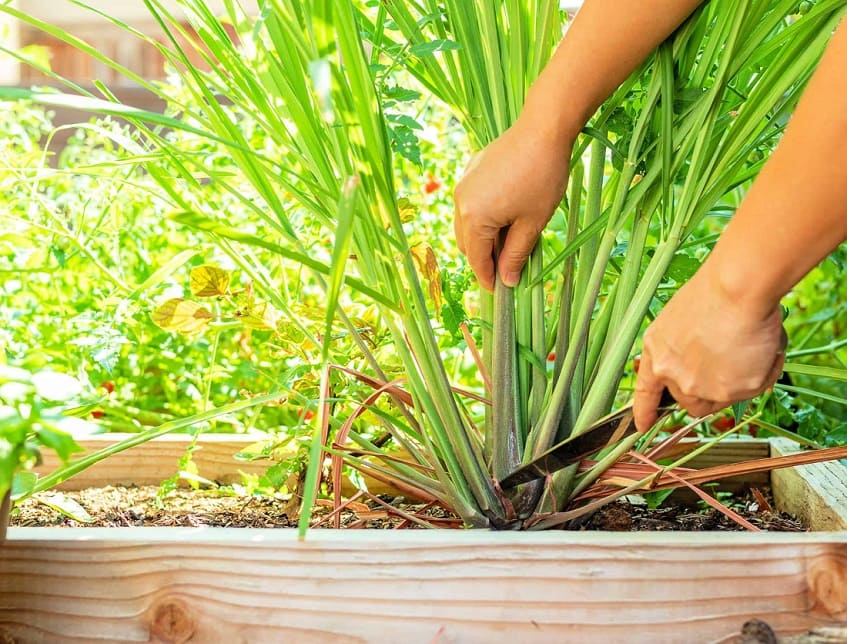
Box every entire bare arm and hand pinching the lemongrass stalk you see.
[455,0,701,290]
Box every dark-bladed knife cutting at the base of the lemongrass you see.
[500,389,676,490]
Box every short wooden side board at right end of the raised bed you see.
[771,439,847,532]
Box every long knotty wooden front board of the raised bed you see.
[0,528,847,644]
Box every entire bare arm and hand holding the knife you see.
[635,20,847,430]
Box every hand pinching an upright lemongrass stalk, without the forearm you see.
[453,119,571,291]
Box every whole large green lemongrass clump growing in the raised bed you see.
[6,0,843,528]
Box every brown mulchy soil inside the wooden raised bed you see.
[6,486,805,532]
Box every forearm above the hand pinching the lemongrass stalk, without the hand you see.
[524,0,701,144]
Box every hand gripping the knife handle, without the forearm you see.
[634,262,786,432]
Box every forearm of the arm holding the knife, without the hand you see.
[704,24,847,312]
